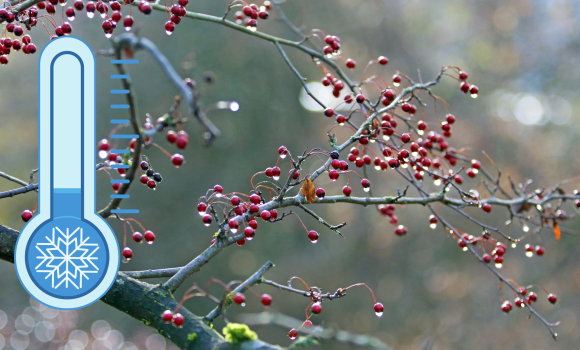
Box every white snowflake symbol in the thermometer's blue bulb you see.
[35,227,99,289]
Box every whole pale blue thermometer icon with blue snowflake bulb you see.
[15,36,119,309]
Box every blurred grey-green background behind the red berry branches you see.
[0,0,580,350]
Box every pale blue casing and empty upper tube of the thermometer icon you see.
[14,36,120,310]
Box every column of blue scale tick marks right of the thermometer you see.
[111,60,139,214]
